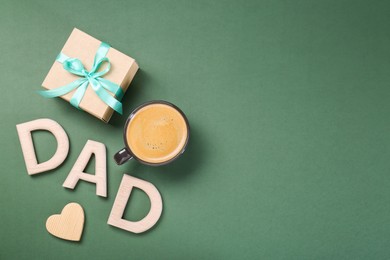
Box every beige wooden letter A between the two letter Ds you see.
[62,140,107,197]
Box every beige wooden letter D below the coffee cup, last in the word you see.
[107,174,162,233]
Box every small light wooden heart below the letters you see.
[46,202,84,241]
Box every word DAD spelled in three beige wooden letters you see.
[16,118,162,233]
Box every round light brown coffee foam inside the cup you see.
[126,104,188,163]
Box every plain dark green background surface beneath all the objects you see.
[0,0,390,259]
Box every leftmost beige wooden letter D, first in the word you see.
[16,118,69,175]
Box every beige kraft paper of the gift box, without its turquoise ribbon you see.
[41,28,138,123]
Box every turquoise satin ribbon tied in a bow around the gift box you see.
[38,42,123,114]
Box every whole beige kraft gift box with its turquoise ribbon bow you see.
[40,28,138,123]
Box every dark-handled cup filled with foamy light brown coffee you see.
[114,100,190,166]
